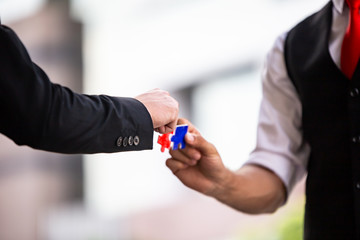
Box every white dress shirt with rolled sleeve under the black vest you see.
[246,0,349,193]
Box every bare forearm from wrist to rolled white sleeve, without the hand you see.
[213,165,286,214]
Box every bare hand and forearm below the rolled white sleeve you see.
[166,119,286,214]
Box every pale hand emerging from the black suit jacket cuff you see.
[135,89,179,133]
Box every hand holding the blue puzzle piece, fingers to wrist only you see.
[166,119,230,197]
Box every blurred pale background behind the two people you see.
[0,0,327,240]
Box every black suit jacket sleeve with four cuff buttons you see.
[0,25,153,153]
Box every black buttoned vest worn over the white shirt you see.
[285,2,360,240]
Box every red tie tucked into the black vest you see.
[341,0,360,79]
